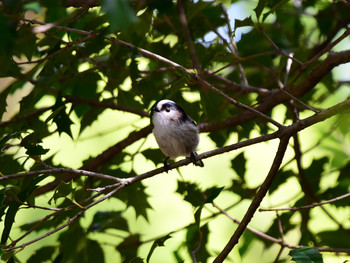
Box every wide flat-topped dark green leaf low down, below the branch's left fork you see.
[89,211,129,232]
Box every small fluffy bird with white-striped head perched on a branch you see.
[151,99,204,172]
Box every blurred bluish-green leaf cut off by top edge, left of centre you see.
[101,0,138,32]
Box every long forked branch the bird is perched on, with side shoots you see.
[4,99,350,254]
